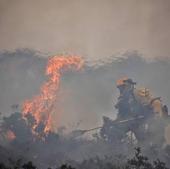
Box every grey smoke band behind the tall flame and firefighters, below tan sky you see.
[0,49,170,129]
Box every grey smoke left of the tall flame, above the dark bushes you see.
[0,49,46,115]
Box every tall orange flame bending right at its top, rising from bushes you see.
[22,55,83,133]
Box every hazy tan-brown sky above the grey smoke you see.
[0,0,170,59]
